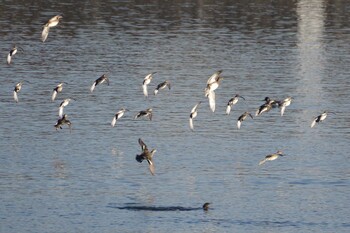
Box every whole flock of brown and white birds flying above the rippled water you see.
[7,15,335,175]
